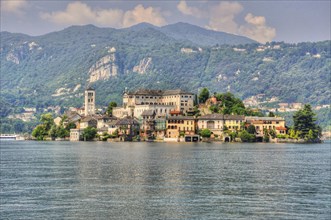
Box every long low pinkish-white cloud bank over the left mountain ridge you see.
[40,1,166,28]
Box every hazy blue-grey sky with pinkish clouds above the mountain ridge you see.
[0,0,331,43]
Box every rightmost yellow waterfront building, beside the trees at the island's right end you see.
[245,116,287,136]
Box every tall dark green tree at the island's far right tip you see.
[293,104,321,140]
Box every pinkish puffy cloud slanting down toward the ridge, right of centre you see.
[177,1,276,43]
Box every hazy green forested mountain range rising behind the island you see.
[0,23,331,113]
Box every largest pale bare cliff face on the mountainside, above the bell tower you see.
[88,48,118,83]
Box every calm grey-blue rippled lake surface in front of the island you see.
[0,141,331,219]
